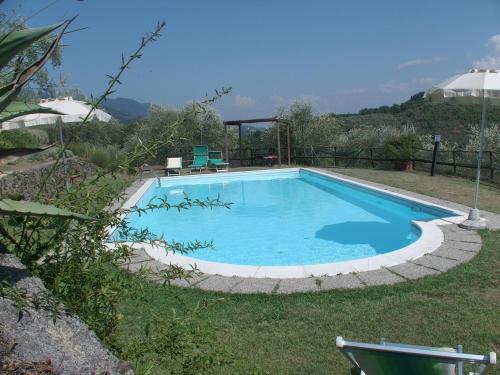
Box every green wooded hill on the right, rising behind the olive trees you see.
[337,93,500,145]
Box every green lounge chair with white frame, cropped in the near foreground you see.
[337,336,496,375]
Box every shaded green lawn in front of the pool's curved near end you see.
[116,231,500,374]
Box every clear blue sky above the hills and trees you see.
[0,0,500,119]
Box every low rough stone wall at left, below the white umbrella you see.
[0,157,97,200]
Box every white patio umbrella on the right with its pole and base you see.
[426,69,500,229]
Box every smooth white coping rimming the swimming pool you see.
[108,168,467,279]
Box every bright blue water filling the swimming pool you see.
[114,170,453,266]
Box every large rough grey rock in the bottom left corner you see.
[0,253,134,375]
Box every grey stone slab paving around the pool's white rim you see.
[117,170,500,294]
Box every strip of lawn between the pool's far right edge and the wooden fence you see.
[330,168,500,213]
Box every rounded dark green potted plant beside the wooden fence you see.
[384,132,422,171]
